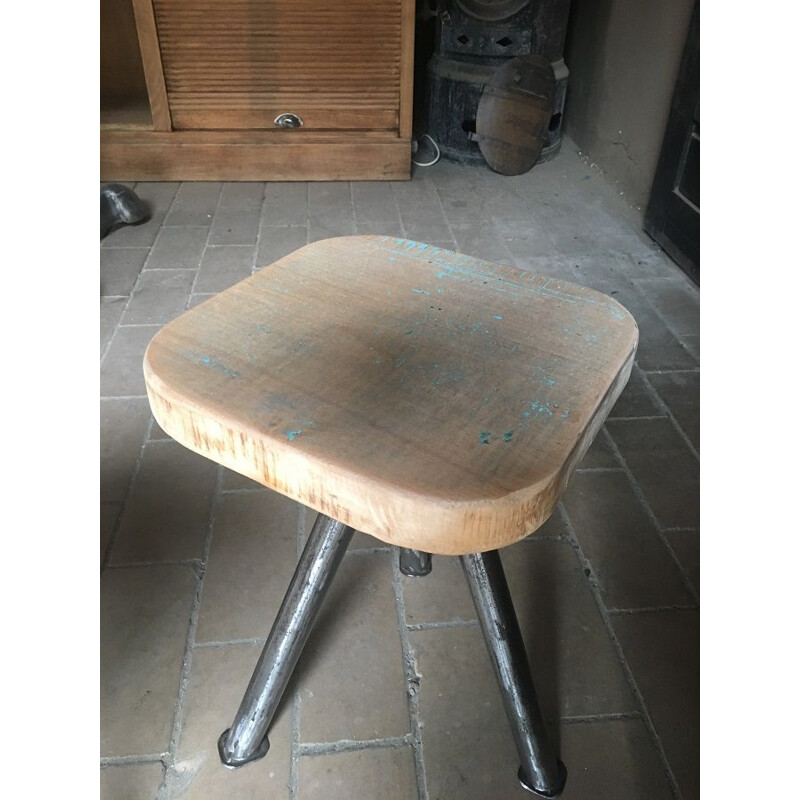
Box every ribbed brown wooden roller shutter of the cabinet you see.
[153,0,401,130]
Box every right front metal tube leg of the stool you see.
[461,550,567,798]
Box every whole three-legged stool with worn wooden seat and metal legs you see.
[144,236,638,797]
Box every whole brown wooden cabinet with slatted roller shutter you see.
[100,0,414,180]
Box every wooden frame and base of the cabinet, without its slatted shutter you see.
[100,0,415,181]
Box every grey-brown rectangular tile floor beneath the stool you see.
[100,140,700,800]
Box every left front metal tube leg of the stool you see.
[217,514,353,767]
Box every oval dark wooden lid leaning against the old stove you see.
[475,55,555,175]
